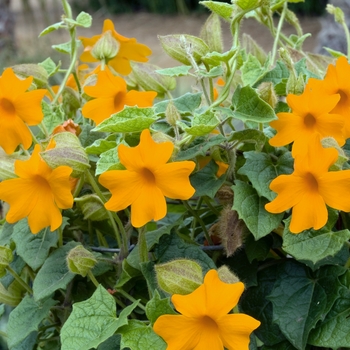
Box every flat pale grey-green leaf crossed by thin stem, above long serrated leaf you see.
[154,92,202,115]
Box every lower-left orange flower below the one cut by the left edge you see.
[0,145,73,234]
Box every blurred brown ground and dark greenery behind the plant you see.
[0,0,334,71]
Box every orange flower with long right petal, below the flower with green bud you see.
[82,68,157,124]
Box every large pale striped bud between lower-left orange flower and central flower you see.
[40,132,90,177]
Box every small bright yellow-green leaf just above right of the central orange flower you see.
[177,110,219,136]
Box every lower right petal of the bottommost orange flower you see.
[216,314,260,350]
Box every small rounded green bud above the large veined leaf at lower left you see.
[66,245,97,277]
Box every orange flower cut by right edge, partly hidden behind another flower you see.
[312,56,350,138]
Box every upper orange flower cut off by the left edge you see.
[0,68,46,154]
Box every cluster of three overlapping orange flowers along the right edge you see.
[265,57,350,233]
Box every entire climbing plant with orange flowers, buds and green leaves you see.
[0,0,350,350]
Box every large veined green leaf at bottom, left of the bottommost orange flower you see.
[61,285,138,350]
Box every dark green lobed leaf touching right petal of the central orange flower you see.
[190,160,226,198]
